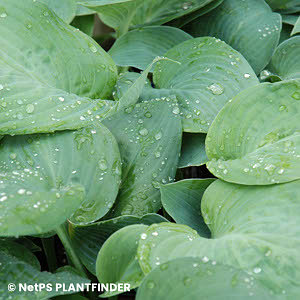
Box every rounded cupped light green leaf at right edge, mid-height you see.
[206,80,300,185]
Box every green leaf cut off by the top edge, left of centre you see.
[80,0,216,35]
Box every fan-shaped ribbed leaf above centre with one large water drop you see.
[141,37,258,132]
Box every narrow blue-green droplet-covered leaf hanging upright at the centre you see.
[104,99,182,216]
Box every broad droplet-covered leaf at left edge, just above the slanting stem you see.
[0,125,121,235]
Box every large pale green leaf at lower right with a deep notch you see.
[138,180,300,299]
